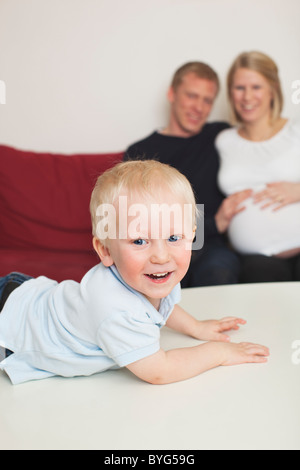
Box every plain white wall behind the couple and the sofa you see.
[0,0,300,153]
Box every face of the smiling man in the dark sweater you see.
[168,73,218,137]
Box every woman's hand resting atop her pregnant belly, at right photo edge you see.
[253,182,300,211]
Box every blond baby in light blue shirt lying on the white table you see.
[0,160,269,384]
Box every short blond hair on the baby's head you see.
[90,160,198,245]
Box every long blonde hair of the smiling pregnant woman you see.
[227,51,283,123]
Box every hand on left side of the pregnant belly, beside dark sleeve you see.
[215,189,253,233]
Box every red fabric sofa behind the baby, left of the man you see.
[0,145,123,281]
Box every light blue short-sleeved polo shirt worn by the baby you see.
[0,264,180,384]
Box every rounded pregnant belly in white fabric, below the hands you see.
[228,199,300,256]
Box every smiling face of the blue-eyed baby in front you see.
[96,190,194,308]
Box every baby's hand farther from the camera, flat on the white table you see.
[198,317,246,342]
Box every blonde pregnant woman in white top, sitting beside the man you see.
[216,52,300,282]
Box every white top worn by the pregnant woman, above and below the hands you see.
[216,121,300,256]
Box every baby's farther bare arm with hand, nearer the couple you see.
[166,305,246,341]
